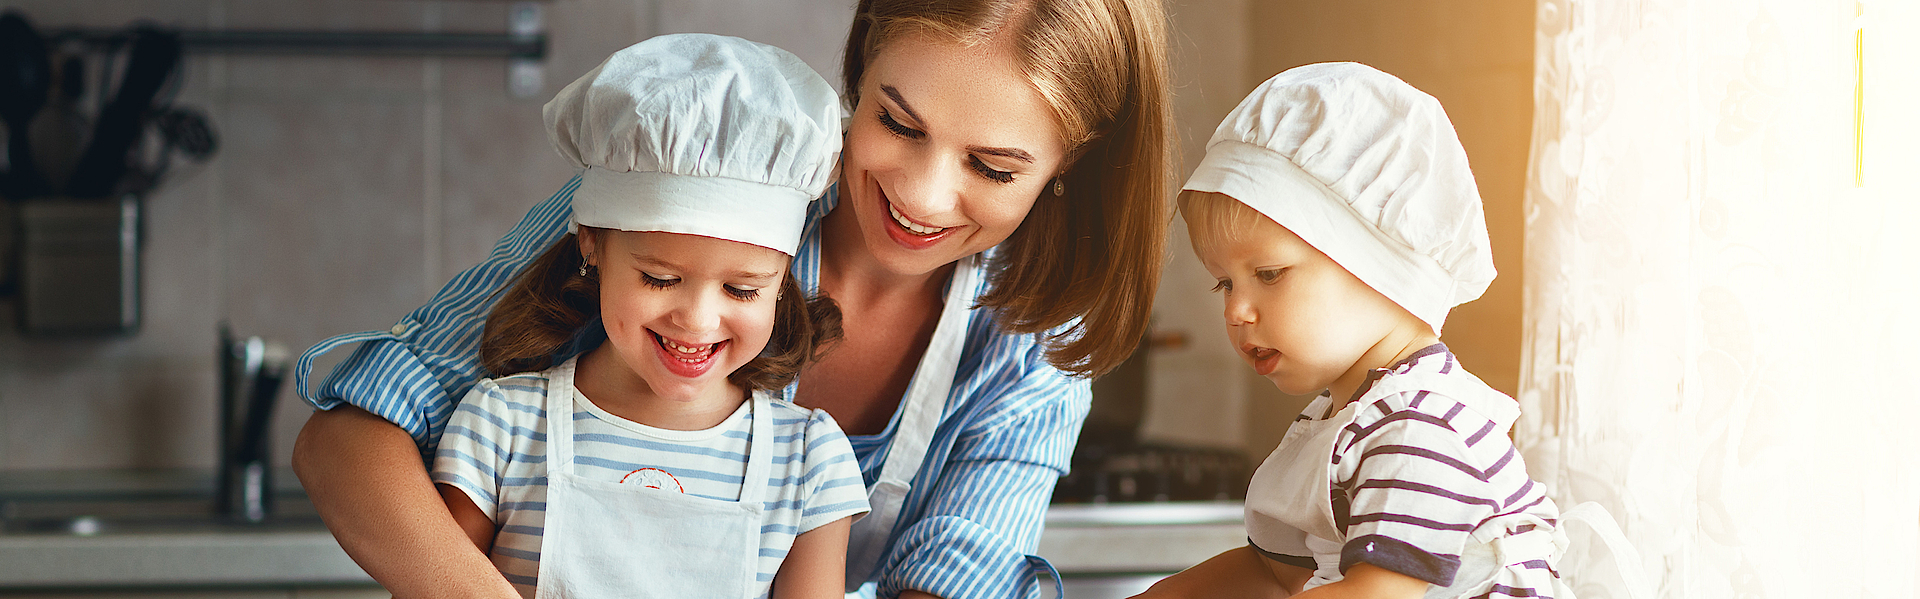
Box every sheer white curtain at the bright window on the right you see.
[1515,0,1920,599]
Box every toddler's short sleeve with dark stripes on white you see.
[1332,395,1526,586]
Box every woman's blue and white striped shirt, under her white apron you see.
[296,179,1091,599]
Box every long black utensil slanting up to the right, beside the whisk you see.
[67,25,180,198]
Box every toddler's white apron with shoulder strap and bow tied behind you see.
[1246,372,1653,599]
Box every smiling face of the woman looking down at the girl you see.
[839,33,1066,275]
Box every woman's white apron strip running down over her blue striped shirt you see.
[847,253,981,593]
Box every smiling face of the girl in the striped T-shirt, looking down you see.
[580,228,789,401]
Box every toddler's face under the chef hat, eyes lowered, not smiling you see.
[1188,192,1405,399]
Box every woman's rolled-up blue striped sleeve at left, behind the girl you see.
[294,177,580,459]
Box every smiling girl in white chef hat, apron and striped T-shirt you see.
[432,35,868,599]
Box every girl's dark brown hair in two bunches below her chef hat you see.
[480,228,841,390]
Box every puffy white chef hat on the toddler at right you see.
[1185,63,1494,334]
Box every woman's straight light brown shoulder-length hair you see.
[843,0,1173,376]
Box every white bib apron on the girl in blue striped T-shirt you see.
[536,359,772,599]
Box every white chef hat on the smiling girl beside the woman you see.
[541,35,841,255]
